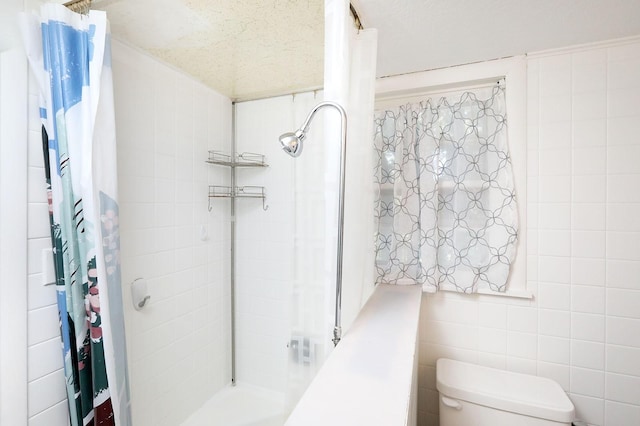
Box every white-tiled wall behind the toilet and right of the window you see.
[419,39,640,426]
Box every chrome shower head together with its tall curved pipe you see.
[280,101,347,346]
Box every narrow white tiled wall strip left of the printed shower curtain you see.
[27,55,69,426]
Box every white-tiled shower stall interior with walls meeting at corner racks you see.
[113,1,376,426]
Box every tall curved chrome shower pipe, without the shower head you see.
[296,101,347,346]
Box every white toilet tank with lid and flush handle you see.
[436,358,575,426]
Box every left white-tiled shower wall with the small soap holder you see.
[113,42,231,426]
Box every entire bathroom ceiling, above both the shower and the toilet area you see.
[92,0,640,99]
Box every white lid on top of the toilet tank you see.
[436,358,574,423]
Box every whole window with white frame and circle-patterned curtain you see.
[376,58,526,296]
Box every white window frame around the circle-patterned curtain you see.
[375,56,533,299]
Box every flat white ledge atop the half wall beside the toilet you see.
[285,284,422,426]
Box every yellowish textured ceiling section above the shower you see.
[92,0,324,99]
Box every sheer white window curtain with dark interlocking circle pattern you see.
[374,80,518,293]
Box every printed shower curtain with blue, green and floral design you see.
[22,4,131,426]
